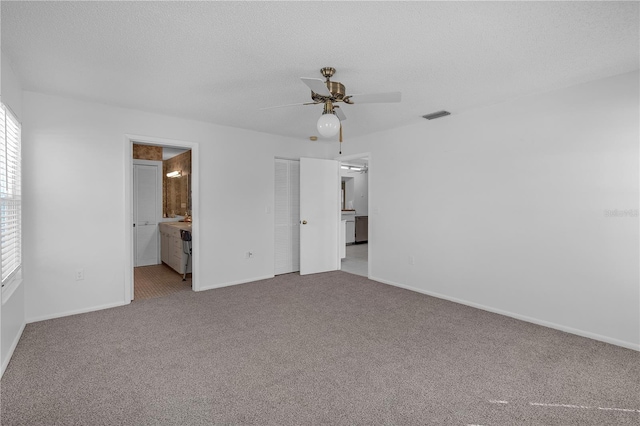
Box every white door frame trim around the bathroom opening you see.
[123,134,200,303]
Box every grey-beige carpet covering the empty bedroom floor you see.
[0,272,640,426]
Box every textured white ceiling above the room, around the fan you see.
[1,1,639,138]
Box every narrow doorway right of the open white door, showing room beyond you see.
[340,154,371,277]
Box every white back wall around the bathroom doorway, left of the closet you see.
[23,92,329,322]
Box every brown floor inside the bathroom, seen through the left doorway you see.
[133,263,191,301]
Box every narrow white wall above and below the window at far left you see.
[0,50,25,377]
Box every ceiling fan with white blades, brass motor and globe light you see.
[261,67,401,138]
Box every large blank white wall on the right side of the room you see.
[343,72,640,349]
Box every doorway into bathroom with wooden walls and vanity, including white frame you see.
[124,135,199,302]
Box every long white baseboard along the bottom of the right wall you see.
[369,277,640,351]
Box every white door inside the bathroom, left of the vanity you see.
[133,162,162,266]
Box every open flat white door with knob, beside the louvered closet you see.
[300,158,340,275]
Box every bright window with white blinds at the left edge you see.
[0,104,22,290]
